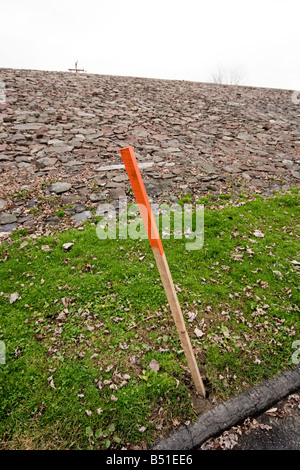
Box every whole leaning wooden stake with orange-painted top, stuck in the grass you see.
[120,147,205,398]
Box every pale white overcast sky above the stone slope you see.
[0,0,300,90]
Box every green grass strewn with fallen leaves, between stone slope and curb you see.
[0,189,300,449]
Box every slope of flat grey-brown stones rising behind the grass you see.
[0,69,300,232]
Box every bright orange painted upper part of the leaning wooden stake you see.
[120,147,164,255]
